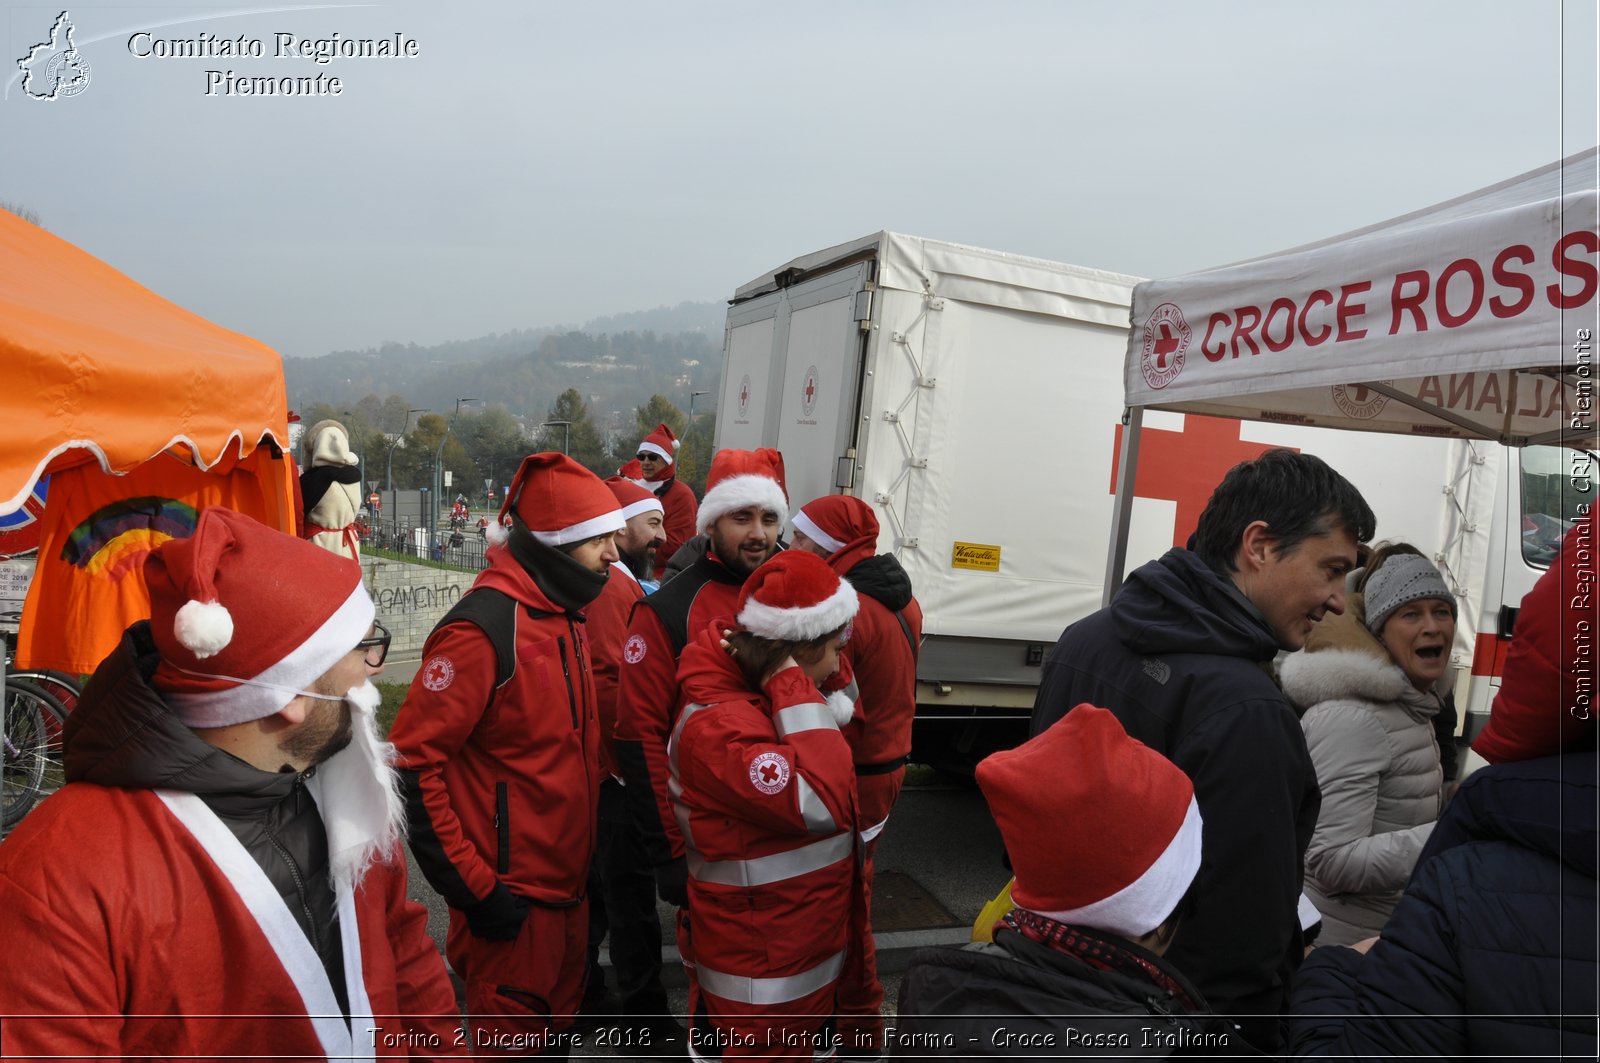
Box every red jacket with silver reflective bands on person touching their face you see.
[669,620,858,1005]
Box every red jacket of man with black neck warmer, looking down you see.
[389,548,600,909]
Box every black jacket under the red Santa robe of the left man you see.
[64,621,349,1009]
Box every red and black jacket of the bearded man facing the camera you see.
[616,550,744,864]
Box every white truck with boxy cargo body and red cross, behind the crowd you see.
[717,232,1592,765]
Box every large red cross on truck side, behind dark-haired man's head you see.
[1110,413,1293,546]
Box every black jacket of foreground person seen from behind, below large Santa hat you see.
[894,930,1251,1060]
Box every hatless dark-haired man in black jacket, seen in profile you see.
[1032,448,1374,1052]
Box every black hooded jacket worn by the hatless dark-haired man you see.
[1032,549,1322,1052]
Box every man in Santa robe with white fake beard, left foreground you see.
[0,507,461,1058]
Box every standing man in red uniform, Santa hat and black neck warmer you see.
[392,453,624,1057]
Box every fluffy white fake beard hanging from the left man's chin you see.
[317,680,406,892]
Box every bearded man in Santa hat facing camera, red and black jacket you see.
[616,447,789,915]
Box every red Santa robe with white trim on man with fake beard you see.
[0,783,464,1060]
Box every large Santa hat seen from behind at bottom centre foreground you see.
[978,704,1200,938]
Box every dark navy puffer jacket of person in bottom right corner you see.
[1290,752,1600,1060]
